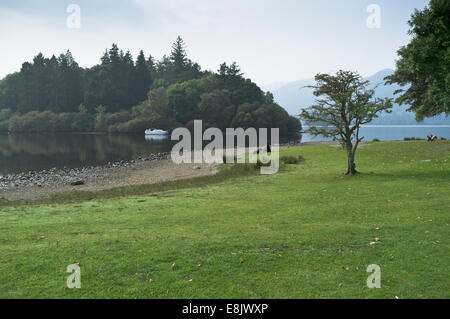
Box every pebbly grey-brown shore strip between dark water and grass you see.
[0,153,217,200]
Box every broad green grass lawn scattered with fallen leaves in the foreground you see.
[0,141,450,298]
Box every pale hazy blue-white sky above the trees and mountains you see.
[0,0,428,85]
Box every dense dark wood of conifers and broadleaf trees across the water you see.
[0,37,301,136]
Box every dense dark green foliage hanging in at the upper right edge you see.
[386,0,450,120]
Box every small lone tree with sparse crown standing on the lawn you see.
[300,70,392,175]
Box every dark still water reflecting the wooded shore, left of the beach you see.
[0,133,173,175]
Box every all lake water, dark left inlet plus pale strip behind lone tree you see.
[0,125,450,175]
